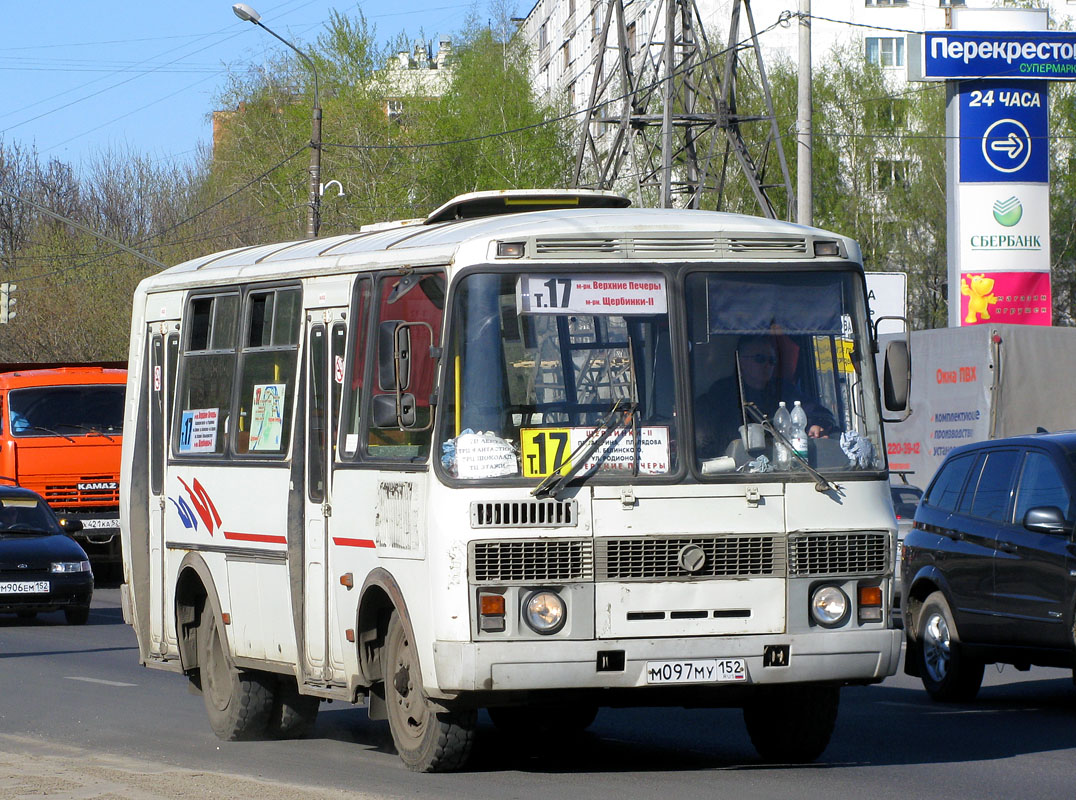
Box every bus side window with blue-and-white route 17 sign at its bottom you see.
[174,291,239,455]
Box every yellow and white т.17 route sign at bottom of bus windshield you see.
[520,425,669,478]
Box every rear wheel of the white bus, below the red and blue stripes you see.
[198,608,273,741]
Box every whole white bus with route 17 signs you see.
[121,191,907,771]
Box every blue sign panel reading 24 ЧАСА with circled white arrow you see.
[958,81,1050,183]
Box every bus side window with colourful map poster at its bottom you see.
[235,286,302,455]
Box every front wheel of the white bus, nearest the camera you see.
[384,613,478,772]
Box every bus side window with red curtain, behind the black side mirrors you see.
[366,272,445,459]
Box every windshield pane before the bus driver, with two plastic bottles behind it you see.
[684,271,883,475]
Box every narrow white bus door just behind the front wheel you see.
[302,308,348,683]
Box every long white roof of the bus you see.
[141,208,860,291]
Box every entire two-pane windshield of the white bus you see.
[439,268,883,480]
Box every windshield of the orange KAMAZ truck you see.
[8,384,125,437]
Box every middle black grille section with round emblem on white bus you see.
[595,535,784,580]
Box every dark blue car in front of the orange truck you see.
[0,486,94,624]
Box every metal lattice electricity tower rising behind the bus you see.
[574,0,795,219]
